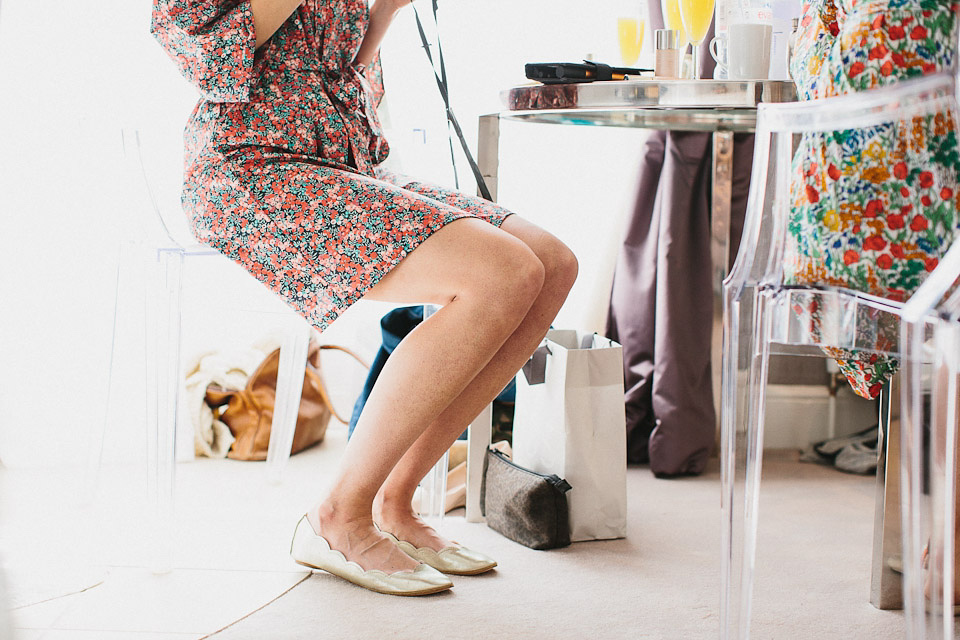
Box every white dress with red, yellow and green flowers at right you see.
[785,0,960,398]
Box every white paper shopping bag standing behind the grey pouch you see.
[513,330,627,542]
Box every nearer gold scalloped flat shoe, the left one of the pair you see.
[290,515,453,596]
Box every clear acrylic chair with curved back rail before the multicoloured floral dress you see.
[720,75,956,638]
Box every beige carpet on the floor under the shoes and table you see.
[201,453,903,640]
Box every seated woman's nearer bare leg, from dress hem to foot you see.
[307,219,544,572]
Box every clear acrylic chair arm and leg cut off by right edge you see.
[900,240,960,639]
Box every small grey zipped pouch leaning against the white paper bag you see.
[480,449,570,549]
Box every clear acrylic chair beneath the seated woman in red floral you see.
[86,129,310,572]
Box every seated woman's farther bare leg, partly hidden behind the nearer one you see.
[372,216,577,551]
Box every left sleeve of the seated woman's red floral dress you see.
[150,0,256,102]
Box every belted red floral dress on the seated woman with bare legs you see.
[151,0,510,330]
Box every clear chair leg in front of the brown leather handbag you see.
[267,318,310,484]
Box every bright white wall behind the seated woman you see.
[0,0,642,466]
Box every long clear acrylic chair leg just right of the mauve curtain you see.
[720,291,770,640]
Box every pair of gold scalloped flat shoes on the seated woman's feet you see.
[290,515,497,596]
